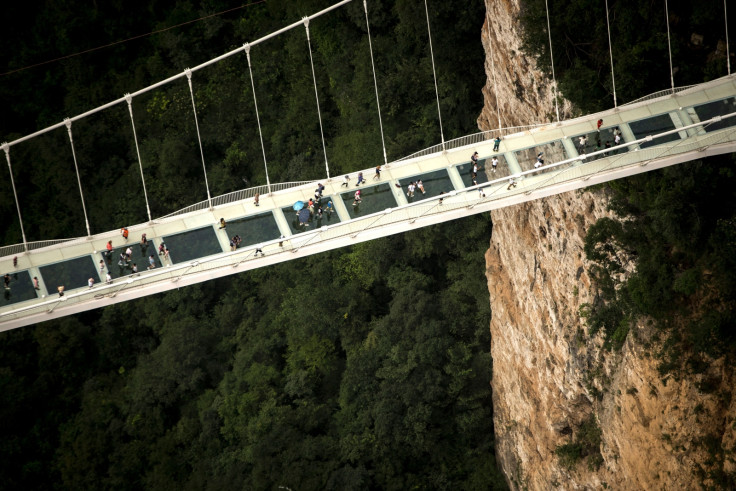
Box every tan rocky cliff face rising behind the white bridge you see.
[478,0,736,490]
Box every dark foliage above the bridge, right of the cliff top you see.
[521,0,733,114]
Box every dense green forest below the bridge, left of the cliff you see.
[0,218,503,489]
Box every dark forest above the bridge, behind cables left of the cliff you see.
[0,0,484,244]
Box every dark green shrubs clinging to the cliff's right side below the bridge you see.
[585,161,736,371]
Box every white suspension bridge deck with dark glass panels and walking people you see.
[0,76,736,331]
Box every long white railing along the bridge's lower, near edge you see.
[0,113,736,321]
